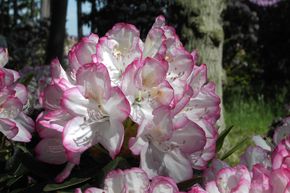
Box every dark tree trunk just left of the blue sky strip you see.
[45,0,67,64]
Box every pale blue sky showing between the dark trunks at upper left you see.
[66,0,91,36]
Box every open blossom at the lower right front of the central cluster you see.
[130,107,205,182]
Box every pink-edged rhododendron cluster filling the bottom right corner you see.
[204,117,290,193]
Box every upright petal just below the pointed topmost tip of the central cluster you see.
[142,28,166,59]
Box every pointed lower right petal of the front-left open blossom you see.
[97,120,124,159]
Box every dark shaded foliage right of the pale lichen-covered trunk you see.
[223,0,290,99]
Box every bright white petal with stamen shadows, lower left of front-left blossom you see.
[63,117,96,152]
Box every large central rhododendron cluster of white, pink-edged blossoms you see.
[36,16,220,182]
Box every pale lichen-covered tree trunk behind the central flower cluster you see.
[177,0,225,129]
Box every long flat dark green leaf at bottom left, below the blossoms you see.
[43,178,91,192]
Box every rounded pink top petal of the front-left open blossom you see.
[76,63,111,100]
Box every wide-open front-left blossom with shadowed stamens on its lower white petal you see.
[61,63,130,157]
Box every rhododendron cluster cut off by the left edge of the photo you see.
[0,48,34,142]
